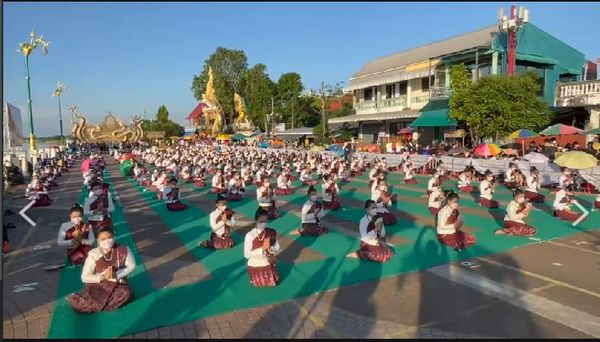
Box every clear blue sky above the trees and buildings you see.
[3,2,600,136]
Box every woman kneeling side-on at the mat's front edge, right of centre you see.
[436,192,476,251]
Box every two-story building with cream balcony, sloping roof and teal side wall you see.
[328,23,586,143]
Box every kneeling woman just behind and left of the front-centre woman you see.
[198,196,235,249]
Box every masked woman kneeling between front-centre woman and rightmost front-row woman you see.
[348,200,394,262]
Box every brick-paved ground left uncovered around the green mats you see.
[2,158,600,338]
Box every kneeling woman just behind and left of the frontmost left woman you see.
[56,203,94,265]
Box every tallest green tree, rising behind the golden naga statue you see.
[191,47,248,122]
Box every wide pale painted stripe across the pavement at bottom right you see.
[427,265,600,338]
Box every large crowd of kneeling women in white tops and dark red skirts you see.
[7,138,600,313]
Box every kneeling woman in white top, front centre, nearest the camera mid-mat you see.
[244,208,281,287]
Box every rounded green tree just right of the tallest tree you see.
[241,63,276,130]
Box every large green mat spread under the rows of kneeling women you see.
[49,167,600,338]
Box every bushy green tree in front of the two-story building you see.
[449,65,552,143]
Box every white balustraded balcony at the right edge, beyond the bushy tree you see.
[555,80,600,107]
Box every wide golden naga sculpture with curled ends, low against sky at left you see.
[73,114,144,143]
